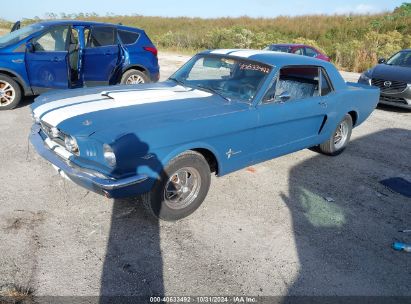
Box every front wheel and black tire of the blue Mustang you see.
[142,151,211,221]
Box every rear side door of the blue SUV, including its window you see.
[82,25,121,86]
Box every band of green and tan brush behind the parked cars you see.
[0,3,411,71]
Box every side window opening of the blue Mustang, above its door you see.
[263,66,319,103]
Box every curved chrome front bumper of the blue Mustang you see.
[30,125,151,198]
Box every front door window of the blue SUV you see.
[33,26,69,52]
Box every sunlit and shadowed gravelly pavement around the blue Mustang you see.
[0,52,411,296]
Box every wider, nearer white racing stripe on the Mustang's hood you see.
[42,90,212,126]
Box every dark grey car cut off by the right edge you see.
[358,49,411,109]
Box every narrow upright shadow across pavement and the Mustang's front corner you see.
[100,134,164,304]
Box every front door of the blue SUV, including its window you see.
[25,25,69,94]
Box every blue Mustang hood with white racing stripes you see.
[32,82,244,136]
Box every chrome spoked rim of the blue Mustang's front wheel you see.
[164,167,201,209]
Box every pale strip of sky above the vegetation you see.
[0,0,405,21]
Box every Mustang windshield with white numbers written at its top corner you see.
[170,54,271,103]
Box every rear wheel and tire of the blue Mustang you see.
[319,114,353,156]
